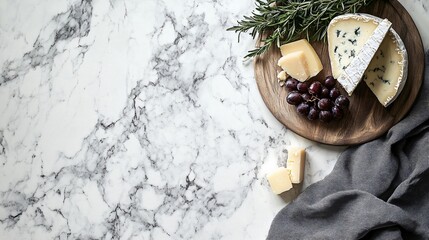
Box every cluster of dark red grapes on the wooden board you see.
[285,76,350,123]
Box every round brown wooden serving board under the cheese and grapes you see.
[254,0,424,145]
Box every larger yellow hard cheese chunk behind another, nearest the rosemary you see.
[280,39,323,80]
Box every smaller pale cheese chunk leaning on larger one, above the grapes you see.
[278,51,310,82]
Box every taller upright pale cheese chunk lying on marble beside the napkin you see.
[286,147,305,184]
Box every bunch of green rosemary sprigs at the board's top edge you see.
[227,0,373,58]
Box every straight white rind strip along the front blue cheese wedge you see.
[338,19,392,96]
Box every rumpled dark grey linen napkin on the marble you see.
[267,52,429,240]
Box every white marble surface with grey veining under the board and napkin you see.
[0,0,429,240]
